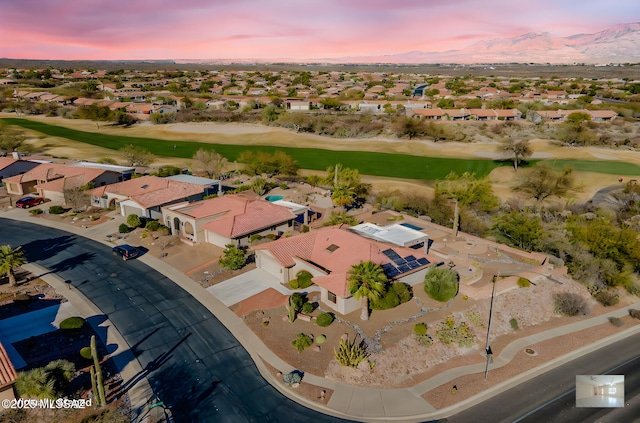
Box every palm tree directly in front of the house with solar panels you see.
[347,261,387,320]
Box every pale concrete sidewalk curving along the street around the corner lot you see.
[4,210,640,422]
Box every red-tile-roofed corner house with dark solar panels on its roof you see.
[254,226,443,315]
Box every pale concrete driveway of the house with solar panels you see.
[207,269,282,307]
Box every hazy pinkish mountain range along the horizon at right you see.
[176,22,640,64]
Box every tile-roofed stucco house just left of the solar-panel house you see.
[162,193,296,247]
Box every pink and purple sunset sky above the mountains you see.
[0,0,640,60]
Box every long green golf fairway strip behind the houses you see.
[3,118,640,180]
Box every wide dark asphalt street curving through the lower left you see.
[0,218,350,423]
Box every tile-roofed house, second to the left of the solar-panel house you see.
[89,176,204,219]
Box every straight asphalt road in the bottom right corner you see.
[447,335,640,423]
